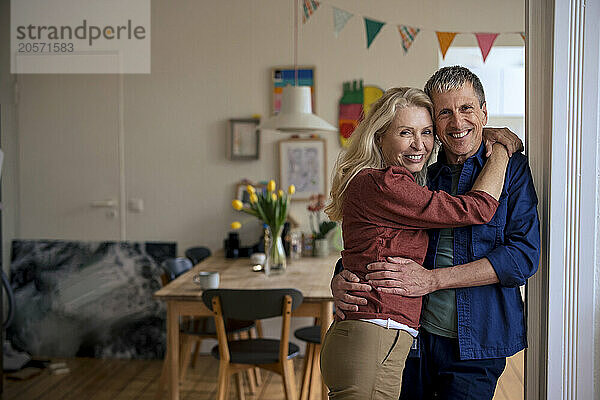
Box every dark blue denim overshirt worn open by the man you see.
[424,145,540,360]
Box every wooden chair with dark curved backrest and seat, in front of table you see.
[202,289,302,400]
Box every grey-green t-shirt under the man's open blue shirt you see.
[421,164,462,338]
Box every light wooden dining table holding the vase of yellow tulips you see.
[154,252,340,400]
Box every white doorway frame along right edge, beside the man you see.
[525,0,600,400]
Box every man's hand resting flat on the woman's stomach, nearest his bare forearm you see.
[365,257,438,297]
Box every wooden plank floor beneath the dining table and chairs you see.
[2,352,523,400]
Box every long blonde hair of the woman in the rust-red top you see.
[325,87,433,221]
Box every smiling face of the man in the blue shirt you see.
[431,83,487,164]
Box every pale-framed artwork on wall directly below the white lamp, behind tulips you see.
[279,138,327,200]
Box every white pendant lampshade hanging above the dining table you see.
[259,86,337,132]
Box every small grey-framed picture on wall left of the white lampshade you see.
[228,118,260,160]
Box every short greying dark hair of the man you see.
[424,65,485,107]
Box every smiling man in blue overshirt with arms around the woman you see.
[331,66,540,400]
